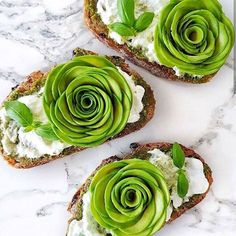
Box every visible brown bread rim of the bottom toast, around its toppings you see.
[68,142,213,233]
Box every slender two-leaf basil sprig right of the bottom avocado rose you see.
[172,143,189,198]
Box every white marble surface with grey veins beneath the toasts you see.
[0,0,236,236]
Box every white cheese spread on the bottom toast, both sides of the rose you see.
[67,149,209,236]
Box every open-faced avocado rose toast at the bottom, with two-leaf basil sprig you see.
[67,143,213,236]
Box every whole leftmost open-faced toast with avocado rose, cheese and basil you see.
[0,49,155,168]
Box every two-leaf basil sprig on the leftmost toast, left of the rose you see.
[4,101,58,141]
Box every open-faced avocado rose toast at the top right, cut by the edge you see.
[84,0,234,83]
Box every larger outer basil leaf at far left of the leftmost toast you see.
[4,101,33,127]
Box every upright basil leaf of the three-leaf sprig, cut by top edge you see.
[117,0,135,26]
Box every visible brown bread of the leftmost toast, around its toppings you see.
[0,48,156,168]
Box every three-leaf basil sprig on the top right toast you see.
[109,0,154,36]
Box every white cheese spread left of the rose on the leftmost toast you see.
[0,93,69,158]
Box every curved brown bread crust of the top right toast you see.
[84,0,215,84]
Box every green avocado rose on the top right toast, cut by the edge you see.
[154,0,234,76]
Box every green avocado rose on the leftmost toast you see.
[44,55,132,147]
